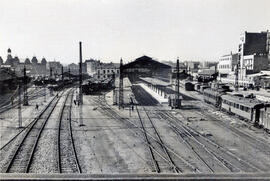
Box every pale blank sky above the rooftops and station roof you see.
[0,0,270,63]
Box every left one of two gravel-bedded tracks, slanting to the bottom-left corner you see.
[1,90,63,173]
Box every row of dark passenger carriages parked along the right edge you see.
[197,82,270,131]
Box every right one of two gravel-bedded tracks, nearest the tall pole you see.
[57,90,82,173]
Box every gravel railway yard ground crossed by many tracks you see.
[0,79,270,178]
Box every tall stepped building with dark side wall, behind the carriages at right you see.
[218,31,270,86]
